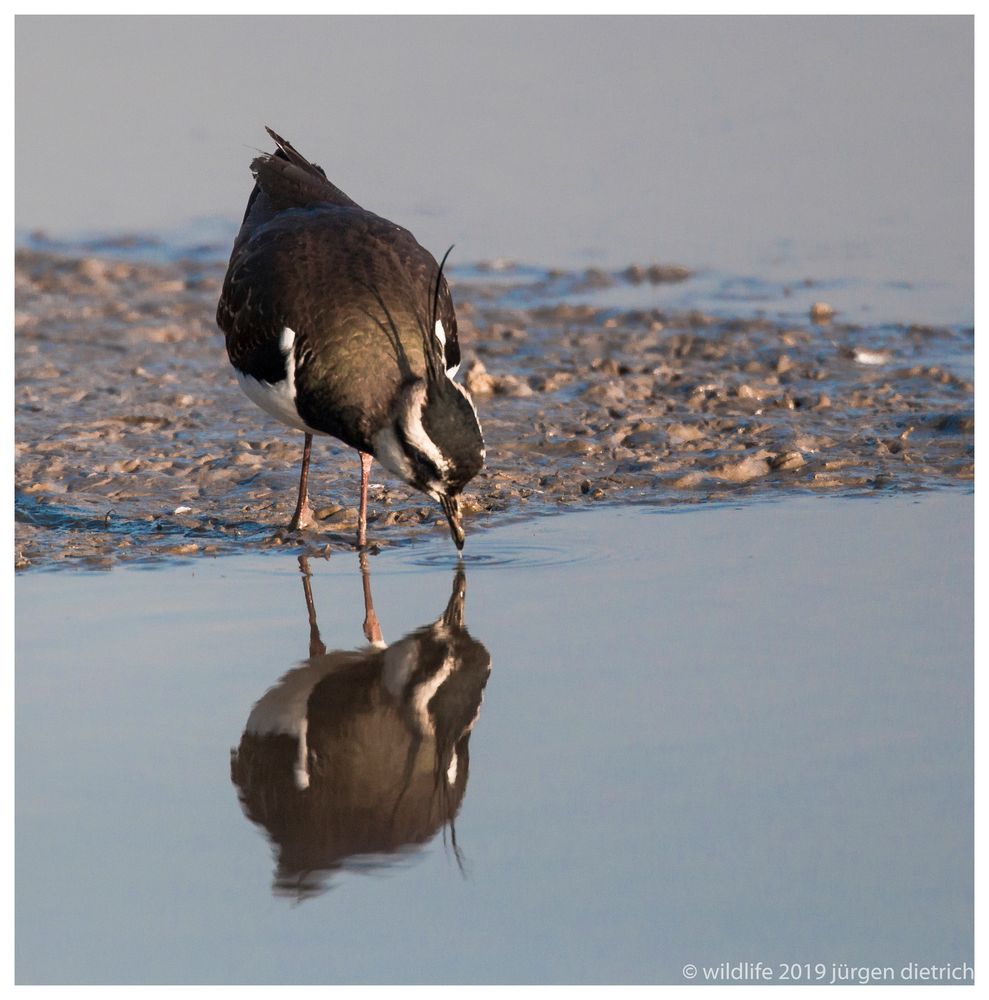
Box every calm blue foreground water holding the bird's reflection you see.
[16,493,973,983]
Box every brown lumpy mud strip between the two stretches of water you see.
[15,240,974,570]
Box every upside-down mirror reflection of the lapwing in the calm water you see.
[231,555,491,899]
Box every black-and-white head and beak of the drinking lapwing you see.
[374,377,484,549]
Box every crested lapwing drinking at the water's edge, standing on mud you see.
[216,127,485,552]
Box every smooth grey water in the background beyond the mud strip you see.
[15,17,974,324]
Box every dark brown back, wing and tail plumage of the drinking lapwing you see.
[217,129,460,451]
